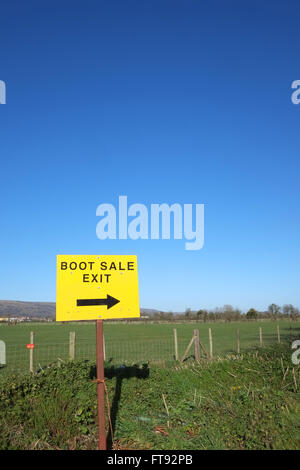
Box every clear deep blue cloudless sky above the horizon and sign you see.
[0,0,300,311]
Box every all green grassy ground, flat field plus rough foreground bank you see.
[0,321,300,449]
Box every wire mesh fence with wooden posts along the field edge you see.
[0,324,300,376]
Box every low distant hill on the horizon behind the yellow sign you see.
[0,300,162,318]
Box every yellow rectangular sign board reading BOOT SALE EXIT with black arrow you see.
[56,255,140,321]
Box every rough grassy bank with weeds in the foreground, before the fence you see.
[0,345,300,449]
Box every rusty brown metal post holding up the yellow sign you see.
[96,320,106,450]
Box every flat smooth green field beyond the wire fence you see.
[0,321,300,373]
